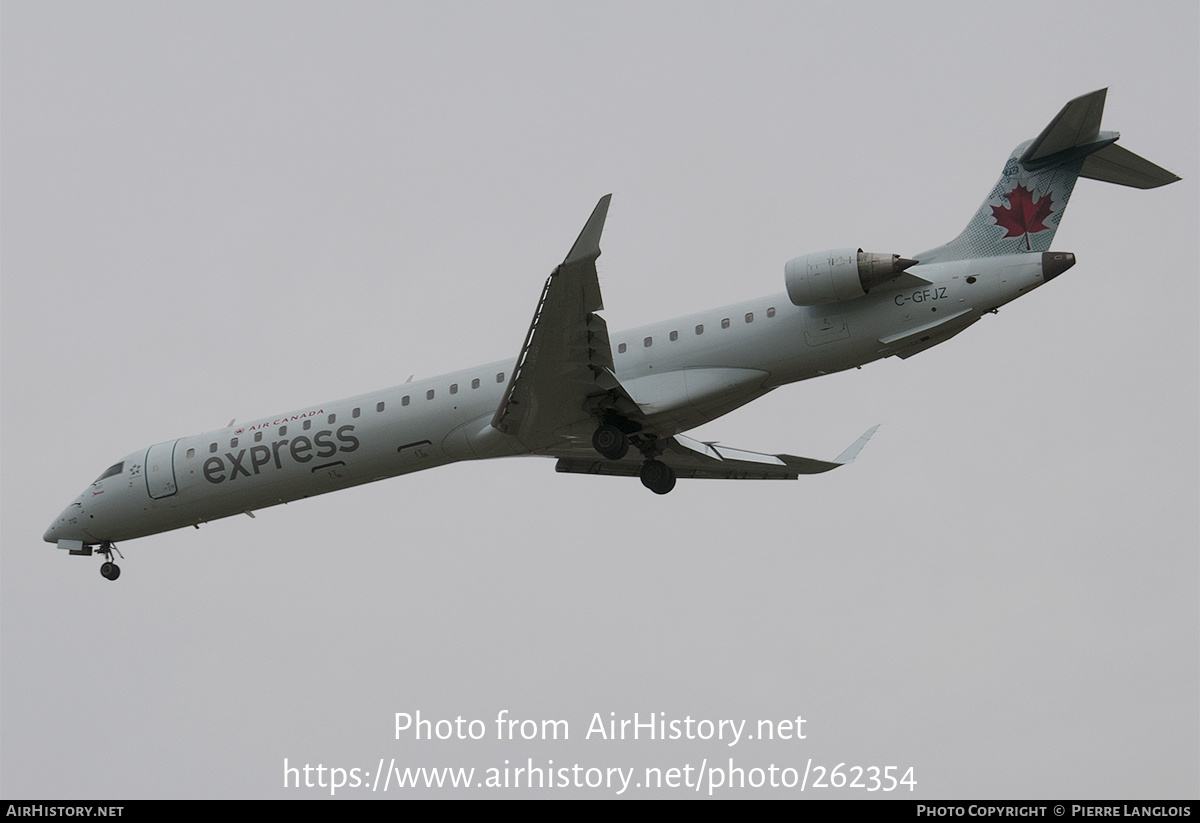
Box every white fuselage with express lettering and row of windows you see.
[46,253,1044,546]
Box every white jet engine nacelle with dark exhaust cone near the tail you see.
[784,248,917,306]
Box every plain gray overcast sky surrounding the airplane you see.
[0,0,1200,798]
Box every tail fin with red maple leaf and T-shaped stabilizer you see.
[916,89,1180,263]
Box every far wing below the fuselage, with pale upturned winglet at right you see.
[554,426,878,480]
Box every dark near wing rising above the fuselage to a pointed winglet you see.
[492,194,637,447]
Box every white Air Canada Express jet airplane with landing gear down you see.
[44,89,1180,579]
